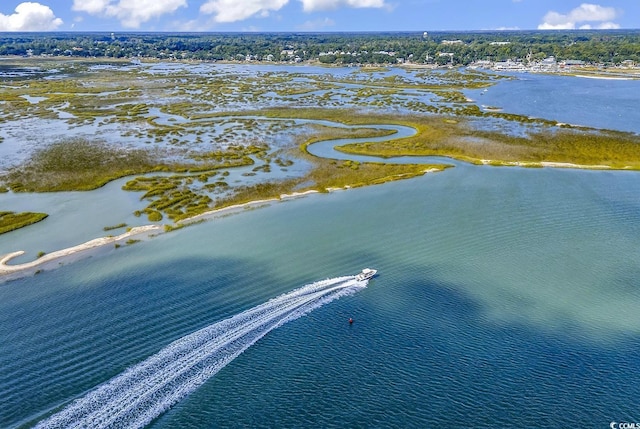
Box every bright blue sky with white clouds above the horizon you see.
[0,0,640,32]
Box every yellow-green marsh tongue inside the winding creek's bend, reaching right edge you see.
[336,111,640,169]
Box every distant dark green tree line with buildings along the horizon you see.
[0,30,640,65]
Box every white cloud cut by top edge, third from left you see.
[200,0,289,22]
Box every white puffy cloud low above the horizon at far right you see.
[538,3,620,30]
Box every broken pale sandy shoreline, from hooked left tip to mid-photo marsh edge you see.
[0,190,319,283]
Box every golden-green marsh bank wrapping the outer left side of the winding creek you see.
[123,120,446,222]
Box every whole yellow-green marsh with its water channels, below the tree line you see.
[0,58,640,232]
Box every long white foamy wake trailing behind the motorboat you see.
[36,276,367,429]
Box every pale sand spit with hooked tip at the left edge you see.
[0,225,162,276]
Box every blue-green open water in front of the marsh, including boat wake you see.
[0,69,640,428]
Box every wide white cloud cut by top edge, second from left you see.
[72,0,187,28]
